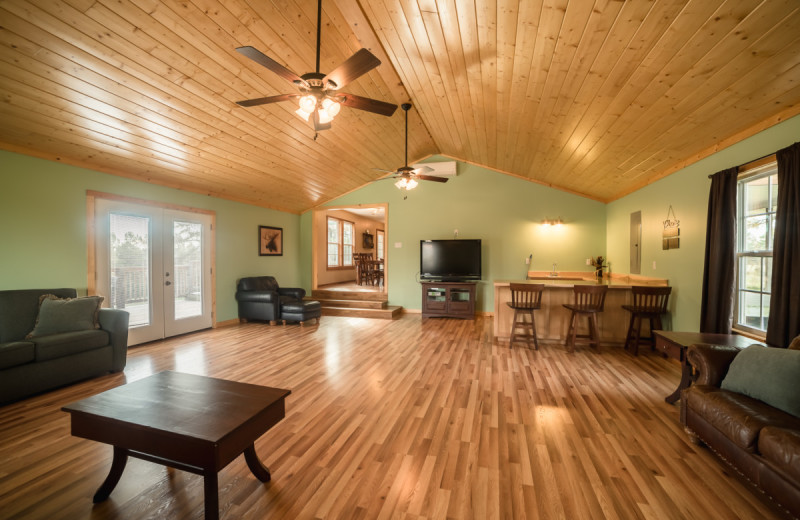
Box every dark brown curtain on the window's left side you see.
[700,167,739,334]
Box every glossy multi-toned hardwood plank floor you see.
[0,315,779,519]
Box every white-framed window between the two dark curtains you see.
[736,162,778,333]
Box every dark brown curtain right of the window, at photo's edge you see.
[767,143,800,348]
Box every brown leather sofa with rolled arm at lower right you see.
[681,345,800,518]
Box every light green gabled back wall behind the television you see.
[318,158,606,312]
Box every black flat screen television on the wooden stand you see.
[419,239,481,282]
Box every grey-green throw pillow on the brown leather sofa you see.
[721,345,800,417]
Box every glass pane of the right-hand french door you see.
[172,220,203,320]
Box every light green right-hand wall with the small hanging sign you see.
[606,116,800,331]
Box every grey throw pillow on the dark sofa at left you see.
[25,294,103,339]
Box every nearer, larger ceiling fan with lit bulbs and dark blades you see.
[236,0,397,131]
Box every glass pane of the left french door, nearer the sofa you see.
[109,213,151,327]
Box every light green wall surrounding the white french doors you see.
[0,151,300,321]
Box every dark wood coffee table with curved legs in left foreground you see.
[62,372,291,520]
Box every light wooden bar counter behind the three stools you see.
[494,271,669,345]
